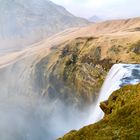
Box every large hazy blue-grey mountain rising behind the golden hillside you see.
[0,0,88,52]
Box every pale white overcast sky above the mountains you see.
[51,0,140,19]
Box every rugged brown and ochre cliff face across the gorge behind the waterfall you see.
[34,33,140,107]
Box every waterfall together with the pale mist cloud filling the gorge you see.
[0,57,140,140]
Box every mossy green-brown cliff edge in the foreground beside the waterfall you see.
[60,84,140,140]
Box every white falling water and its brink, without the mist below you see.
[88,64,140,124]
